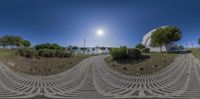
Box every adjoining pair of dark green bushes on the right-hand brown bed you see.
[110,48,142,59]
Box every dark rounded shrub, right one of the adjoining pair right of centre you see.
[128,48,142,59]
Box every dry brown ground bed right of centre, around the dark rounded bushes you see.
[105,53,176,75]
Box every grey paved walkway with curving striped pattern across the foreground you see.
[0,54,200,99]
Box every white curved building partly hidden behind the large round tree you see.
[141,26,174,52]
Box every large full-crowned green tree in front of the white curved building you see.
[151,26,182,53]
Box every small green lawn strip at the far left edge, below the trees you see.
[0,49,15,59]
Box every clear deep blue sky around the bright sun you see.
[0,0,200,47]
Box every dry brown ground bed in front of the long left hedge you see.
[3,55,92,76]
